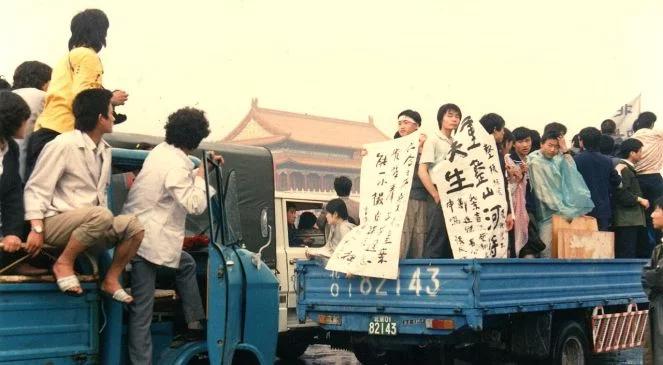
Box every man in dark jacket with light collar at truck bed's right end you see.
[613,138,649,259]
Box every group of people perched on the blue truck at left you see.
[0,9,223,364]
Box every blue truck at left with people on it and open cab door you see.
[0,145,279,365]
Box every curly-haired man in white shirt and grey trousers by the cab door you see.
[123,108,222,365]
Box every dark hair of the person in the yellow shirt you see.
[69,9,110,52]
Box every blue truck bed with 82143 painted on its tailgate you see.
[296,259,647,364]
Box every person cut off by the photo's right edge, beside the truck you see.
[642,197,663,364]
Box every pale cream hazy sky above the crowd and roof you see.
[0,0,663,139]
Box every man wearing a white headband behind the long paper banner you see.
[394,109,428,260]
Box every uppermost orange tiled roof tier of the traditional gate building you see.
[222,99,389,149]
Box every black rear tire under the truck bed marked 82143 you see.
[550,320,590,365]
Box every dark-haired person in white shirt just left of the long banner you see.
[306,198,355,260]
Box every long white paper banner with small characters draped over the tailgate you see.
[326,133,419,279]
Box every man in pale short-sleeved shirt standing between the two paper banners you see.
[417,104,463,258]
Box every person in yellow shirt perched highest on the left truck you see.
[25,9,128,180]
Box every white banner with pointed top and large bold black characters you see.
[432,116,508,259]
